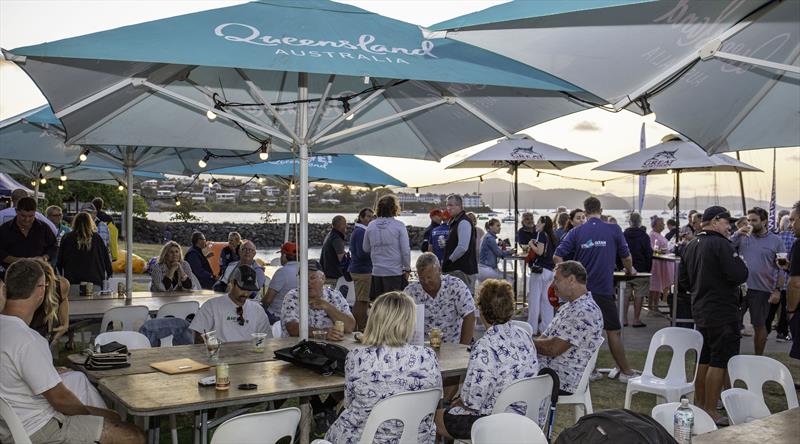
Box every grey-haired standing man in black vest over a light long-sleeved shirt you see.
[442,194,478,293]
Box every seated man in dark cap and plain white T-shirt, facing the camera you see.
[189,265,272,343]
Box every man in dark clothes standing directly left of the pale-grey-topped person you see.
[347,208,375,331]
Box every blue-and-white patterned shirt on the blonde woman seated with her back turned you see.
[325,345,442,444]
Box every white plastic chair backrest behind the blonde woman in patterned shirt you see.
[360,389,442,444]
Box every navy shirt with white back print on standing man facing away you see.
[555,217,630,296]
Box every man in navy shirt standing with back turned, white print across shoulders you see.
[553,197,639,383]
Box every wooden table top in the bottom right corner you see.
[692,407,800,444]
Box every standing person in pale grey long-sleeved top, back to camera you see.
[362,194,411,300]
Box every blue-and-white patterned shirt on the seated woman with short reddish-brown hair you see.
[449,323,539,415]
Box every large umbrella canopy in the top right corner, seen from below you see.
[432,0,800,153]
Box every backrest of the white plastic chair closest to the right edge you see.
[728,355,798,409]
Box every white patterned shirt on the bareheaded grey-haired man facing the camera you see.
[403,274,475,344]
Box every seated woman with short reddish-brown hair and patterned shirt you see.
[436,279,539,439]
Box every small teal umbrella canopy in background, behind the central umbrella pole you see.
[209,154,406,188]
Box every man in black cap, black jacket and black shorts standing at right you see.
[679,206,748,425]
